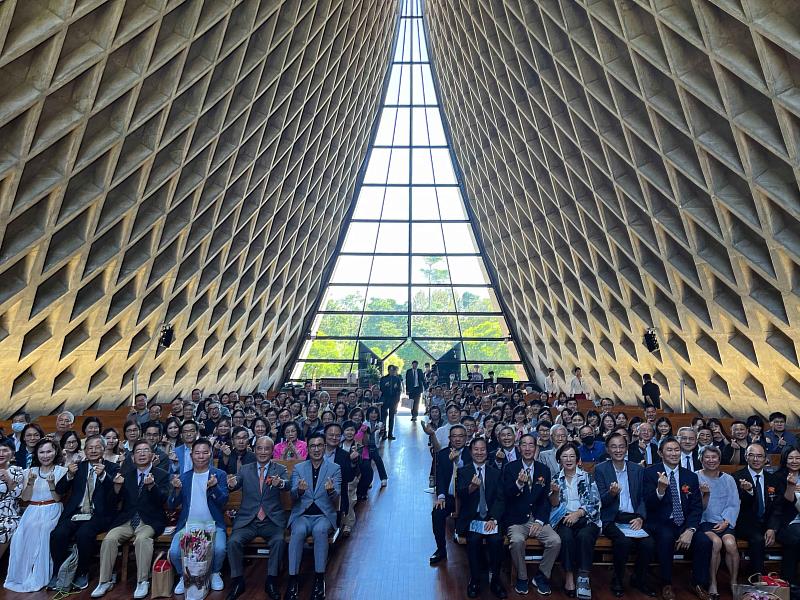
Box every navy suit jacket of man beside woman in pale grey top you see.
[644,463,703,531]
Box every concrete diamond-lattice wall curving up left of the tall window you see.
[0,0,396,415]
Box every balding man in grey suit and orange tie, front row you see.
[227,436,289,600]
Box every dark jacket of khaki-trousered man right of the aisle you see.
[503,459,552,526]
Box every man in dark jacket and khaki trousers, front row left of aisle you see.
[92,440,169,598]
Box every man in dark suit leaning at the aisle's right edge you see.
[429,425,470,565]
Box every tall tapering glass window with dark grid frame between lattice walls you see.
[292,0,528,380]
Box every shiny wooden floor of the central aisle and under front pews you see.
[0,411,730,600]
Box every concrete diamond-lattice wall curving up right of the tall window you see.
[427,0,800,415]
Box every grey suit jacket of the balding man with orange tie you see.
[231,460,289,530]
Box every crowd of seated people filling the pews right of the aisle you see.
[422,376,800,600]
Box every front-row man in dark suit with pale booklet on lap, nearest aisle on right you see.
[456,438,508,598]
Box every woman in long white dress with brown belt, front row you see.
[4,438,67,592]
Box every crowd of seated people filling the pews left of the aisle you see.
[0,384,388,600]
